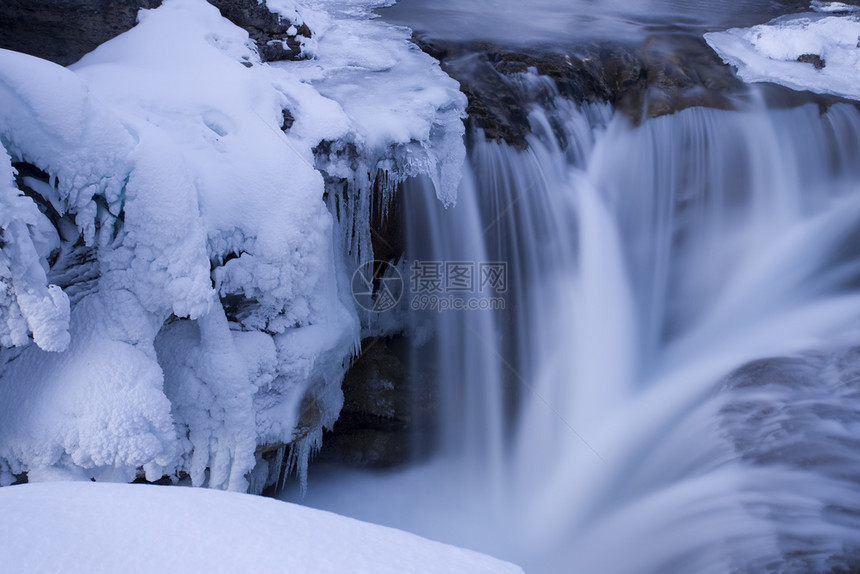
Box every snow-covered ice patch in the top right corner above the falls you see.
[705,13,860,99]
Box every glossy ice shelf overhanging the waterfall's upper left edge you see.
[286,0,466,212]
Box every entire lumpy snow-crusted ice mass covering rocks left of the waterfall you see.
[0,0,465,496]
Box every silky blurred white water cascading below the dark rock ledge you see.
[286,97,860,574]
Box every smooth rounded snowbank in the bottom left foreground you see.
[0,482,522,574]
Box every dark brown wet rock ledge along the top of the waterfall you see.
[413,30,846,149]
